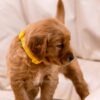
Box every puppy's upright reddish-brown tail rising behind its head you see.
[56,0,65,23]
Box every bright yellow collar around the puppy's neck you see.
[19,31,41,64]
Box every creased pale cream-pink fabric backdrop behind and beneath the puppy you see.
[0,0,100,100]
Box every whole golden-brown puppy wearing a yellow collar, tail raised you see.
[7,0,89,100]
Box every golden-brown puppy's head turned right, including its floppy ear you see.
[26,19,74,65]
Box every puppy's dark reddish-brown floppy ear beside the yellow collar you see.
[29,35,47,60]
